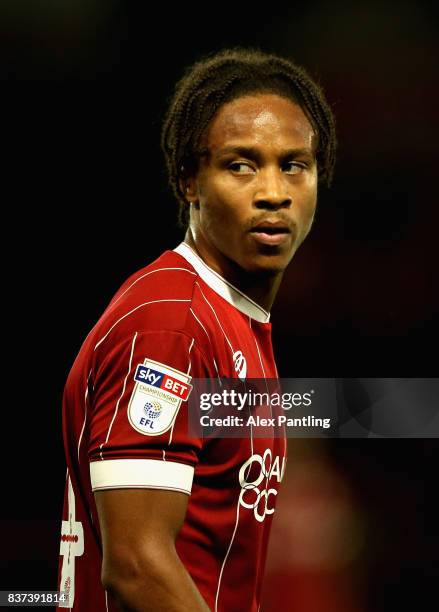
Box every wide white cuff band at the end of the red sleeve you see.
[90,459,194,494]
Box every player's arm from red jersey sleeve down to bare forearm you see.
[87,331,215,612]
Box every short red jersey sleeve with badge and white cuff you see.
[89,331,209,494]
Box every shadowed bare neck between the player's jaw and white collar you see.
[184,228,283,312]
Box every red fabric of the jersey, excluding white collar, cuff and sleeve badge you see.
[59,246,286,612]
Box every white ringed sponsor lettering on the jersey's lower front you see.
[239,448,286,523]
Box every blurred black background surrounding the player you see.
[0,0,439,612]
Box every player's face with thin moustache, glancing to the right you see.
[186,93,317,277]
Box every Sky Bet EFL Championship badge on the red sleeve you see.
[128,359,192,436]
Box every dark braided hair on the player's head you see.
[161,47,337,227]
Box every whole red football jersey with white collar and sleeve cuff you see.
[59,243,286,612]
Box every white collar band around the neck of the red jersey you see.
[174,242,270,323]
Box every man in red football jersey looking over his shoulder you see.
[59,49,335,612]
